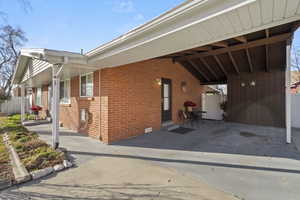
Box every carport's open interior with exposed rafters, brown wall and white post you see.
[163,22,299,143]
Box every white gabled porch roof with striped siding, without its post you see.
[13,49,97,87]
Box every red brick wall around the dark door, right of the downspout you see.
[101,59,202,143]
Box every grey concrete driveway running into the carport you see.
[0,121,300,200]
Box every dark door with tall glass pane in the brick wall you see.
[161,78,172,122]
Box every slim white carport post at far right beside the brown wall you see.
[285,41,292,144]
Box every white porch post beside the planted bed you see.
[52,65,62,149]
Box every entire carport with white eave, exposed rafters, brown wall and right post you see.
[87,0,300,143]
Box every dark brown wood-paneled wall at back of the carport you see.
[228,69,285,127]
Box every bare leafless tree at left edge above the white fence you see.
[0,25,27,100]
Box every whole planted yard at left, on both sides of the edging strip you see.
[0,115,64,186]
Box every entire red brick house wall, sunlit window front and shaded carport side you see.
[33,59,202,143]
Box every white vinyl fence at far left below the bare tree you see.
[0,97,30,115]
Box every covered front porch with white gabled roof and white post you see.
[13,49,96,148]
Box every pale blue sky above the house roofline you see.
[0,0,184,52]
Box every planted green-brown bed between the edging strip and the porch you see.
[0,115,64,172]
